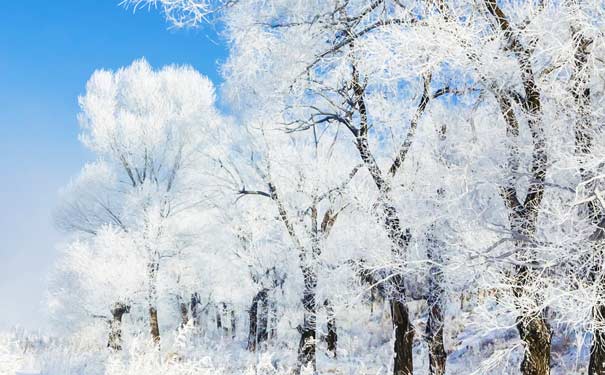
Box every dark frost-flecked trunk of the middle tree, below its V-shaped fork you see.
[298,267,317,372]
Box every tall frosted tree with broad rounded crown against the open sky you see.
[58,60,220,341]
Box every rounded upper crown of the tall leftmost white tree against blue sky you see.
[80,59,217,190]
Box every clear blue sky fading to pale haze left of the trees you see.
[0,0,227,329]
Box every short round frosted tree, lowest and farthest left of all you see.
[49,225,145,350]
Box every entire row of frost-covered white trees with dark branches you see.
[53,0,605,375]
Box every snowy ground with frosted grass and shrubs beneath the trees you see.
[0,306,589,375]
